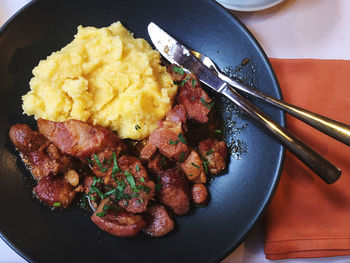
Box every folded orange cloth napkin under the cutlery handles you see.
[264,59,350,259]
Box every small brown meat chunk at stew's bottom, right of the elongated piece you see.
[143,204,174,237]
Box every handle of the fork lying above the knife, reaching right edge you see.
[218,73,350,146]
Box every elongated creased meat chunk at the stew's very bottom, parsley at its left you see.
[91,199,146,237]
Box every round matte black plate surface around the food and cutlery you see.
[0,0,284,262]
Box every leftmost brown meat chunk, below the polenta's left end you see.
[9,124,48,154]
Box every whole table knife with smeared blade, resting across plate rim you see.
[148,22,341,184]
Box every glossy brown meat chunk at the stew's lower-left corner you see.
[33,176,76,208]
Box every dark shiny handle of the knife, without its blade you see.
[221,85,341,184]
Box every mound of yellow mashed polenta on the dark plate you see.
[22,22,177,140]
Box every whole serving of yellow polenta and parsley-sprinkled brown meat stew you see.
[9,23,227,237]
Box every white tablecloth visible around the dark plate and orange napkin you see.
[0,0,350,263]
